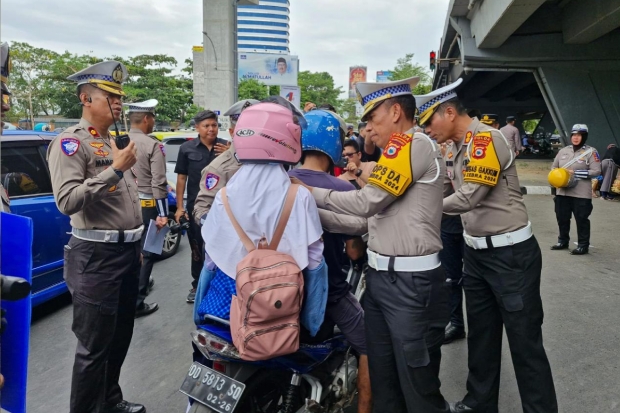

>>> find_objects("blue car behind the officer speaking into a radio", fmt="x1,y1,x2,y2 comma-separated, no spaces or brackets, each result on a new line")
0,130,71,306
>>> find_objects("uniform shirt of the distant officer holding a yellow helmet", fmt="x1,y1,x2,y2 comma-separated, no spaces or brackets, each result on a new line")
553,145,601,199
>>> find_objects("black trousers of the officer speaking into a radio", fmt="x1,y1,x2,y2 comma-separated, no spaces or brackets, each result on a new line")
64,237,140,413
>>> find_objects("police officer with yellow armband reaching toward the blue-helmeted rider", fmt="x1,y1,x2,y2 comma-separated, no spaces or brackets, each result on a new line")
296,77,450,413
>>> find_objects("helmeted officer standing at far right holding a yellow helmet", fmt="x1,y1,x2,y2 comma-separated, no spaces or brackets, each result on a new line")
551,124,601,255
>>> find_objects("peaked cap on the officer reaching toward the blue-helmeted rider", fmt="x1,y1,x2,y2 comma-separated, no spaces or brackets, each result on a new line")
355,76,420,122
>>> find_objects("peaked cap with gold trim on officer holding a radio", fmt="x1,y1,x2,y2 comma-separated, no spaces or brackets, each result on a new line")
67,60,129,96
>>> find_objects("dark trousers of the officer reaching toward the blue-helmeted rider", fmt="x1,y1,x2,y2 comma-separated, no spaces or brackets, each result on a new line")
363,267,450,413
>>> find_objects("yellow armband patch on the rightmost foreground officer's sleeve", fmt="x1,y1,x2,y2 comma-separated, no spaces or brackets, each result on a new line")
463,131,501,186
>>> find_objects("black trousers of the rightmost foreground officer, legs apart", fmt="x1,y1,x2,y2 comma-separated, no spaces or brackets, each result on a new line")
463,237,558,413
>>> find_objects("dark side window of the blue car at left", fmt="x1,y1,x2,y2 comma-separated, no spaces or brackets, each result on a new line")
1,144,52,198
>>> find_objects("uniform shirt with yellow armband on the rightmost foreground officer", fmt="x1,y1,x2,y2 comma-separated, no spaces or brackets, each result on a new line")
443,118,528,237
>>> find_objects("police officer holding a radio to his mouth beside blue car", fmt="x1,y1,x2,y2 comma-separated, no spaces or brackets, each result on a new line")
47,61,146,413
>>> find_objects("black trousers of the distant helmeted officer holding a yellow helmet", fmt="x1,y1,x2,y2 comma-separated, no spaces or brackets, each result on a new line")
554,195,592,247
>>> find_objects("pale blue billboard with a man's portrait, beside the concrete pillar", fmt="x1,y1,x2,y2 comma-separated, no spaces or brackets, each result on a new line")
239,53,299,86
